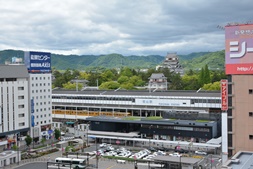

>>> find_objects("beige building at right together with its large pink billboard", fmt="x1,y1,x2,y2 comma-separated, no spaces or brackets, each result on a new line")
223,24,253,156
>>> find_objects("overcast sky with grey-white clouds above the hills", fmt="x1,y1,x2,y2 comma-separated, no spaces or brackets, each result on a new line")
0,0,253,56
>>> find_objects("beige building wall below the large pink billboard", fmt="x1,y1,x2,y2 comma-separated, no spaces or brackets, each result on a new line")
228,75,253,156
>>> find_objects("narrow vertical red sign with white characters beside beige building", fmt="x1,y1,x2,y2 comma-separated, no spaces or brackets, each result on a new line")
221,79,228,111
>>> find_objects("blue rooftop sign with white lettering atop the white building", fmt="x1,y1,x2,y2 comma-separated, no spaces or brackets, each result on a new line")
24,52,51,72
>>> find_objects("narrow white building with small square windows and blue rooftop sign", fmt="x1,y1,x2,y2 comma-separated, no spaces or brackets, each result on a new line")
24,52,52,139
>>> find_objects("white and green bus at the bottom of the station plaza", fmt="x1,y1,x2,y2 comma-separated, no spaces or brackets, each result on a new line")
55,157,86,169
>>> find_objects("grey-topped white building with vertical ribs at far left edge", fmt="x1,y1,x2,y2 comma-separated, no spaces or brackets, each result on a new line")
0,65,30,152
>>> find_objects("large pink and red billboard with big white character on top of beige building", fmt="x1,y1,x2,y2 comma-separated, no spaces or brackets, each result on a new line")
225,24,253,74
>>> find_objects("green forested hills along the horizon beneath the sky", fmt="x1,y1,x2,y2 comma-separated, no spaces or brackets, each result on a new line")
0,50,225,70
